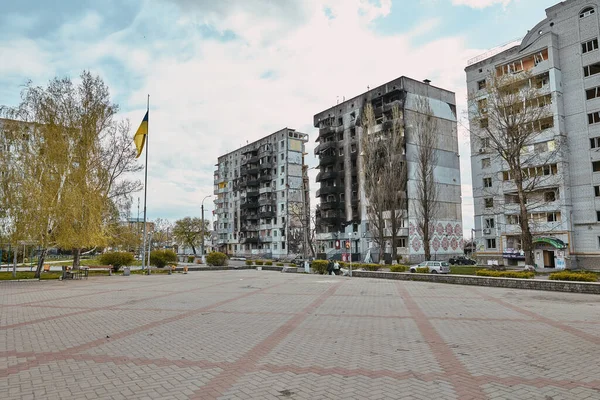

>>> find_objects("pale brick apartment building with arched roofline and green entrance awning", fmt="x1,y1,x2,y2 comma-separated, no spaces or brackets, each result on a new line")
465,0,600,269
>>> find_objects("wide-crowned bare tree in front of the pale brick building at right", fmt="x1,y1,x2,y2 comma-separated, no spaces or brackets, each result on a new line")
469,72,565,265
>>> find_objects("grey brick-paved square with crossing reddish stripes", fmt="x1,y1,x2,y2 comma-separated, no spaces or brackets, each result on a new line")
0,270,600,400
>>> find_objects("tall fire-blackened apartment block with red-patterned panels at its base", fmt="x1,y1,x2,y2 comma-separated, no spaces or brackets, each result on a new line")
314,77,463,262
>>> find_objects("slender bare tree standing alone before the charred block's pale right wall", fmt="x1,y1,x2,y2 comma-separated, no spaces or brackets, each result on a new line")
411,96,439,260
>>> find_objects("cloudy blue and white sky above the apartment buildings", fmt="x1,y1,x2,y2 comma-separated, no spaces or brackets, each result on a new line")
0,0,557,236
